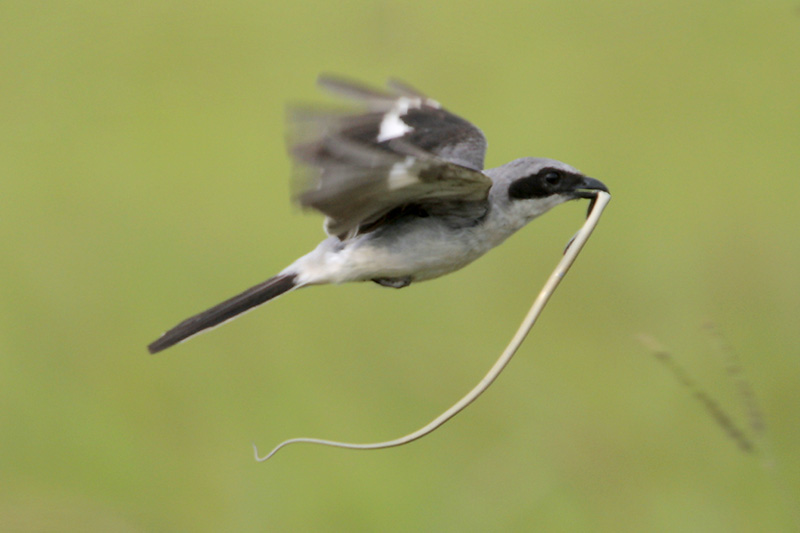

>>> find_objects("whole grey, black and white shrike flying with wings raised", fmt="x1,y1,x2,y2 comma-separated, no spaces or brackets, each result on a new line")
148,77,608,353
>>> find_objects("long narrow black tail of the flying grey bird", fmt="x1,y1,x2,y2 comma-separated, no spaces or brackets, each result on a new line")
147,274,297,353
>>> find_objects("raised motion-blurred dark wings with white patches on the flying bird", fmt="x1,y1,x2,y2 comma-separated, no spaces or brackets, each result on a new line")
290,77,492,238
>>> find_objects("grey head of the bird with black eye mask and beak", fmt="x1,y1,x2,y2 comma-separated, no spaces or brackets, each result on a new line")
486,157,608,220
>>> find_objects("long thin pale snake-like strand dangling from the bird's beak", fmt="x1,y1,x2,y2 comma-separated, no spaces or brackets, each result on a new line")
253,192,611,462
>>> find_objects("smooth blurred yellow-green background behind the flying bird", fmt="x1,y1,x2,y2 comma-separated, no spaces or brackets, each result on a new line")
0,0,800,532
